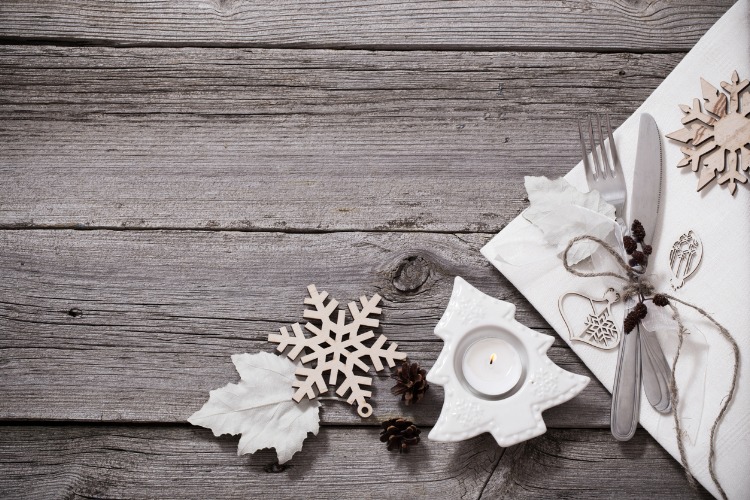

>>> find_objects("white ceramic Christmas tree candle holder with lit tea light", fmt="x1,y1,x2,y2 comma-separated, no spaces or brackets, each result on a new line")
427,277,589,446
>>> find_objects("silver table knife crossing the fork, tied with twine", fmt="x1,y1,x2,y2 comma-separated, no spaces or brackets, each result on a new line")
610,113,663,441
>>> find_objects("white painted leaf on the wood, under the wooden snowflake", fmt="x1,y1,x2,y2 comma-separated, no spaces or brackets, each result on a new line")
188,352,320,464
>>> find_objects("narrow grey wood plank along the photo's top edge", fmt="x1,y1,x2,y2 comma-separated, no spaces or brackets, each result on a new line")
0,0,733,51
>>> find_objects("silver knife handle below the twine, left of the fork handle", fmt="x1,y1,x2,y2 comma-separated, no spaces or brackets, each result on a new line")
610,327,641,441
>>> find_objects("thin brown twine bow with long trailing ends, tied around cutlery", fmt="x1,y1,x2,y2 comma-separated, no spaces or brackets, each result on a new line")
563,235,740,499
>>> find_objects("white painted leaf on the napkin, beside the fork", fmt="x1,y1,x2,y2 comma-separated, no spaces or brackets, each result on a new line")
523,177,615,264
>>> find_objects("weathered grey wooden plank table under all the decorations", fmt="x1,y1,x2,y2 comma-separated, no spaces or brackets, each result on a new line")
0,0,732,498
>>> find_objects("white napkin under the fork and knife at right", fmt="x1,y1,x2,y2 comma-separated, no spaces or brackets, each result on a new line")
482,0,750,498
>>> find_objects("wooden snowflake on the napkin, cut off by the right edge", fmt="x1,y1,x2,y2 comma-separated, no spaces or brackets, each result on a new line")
667,71,750,195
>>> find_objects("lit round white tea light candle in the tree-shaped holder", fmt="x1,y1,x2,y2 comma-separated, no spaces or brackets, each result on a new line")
461,337,523,396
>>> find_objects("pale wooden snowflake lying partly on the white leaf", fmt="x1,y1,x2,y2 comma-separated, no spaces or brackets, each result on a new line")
268,285,406,417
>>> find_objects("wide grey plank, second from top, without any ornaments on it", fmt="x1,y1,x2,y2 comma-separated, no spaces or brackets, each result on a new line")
0,44,682,233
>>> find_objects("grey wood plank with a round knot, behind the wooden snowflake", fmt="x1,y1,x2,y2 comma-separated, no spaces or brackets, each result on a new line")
0,230,609,427
